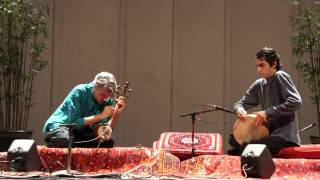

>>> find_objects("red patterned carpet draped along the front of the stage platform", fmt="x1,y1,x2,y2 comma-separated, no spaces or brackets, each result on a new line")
0,146,320,179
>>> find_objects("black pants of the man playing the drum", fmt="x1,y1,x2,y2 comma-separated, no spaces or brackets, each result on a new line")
228,134,299,156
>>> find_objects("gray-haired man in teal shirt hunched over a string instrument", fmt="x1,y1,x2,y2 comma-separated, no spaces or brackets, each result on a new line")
43,72,125,147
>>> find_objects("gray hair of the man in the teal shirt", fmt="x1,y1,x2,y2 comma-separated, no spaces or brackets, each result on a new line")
92,72,117,95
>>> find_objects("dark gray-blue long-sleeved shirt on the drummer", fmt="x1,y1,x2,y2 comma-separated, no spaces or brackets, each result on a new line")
234,71,302,145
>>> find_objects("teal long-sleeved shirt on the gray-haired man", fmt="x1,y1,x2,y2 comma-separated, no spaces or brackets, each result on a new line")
42,83,113,133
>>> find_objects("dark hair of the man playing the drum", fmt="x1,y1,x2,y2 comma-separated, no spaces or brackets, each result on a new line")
256,47,281,71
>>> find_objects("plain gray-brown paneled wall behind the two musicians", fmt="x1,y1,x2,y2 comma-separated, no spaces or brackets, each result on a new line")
29,0,317,152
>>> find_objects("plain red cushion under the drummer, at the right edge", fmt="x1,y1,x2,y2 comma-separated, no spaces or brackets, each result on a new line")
276,144,320,159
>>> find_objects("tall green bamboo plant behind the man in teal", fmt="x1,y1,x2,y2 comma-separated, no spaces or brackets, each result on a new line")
0,0,49,131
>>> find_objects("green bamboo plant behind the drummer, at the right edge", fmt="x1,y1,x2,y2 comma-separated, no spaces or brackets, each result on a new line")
291,0,320,132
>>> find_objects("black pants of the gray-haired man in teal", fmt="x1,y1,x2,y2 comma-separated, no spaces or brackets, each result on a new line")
45,127,114,148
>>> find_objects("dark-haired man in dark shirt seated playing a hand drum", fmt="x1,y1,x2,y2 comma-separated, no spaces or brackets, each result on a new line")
228,47,302,155
